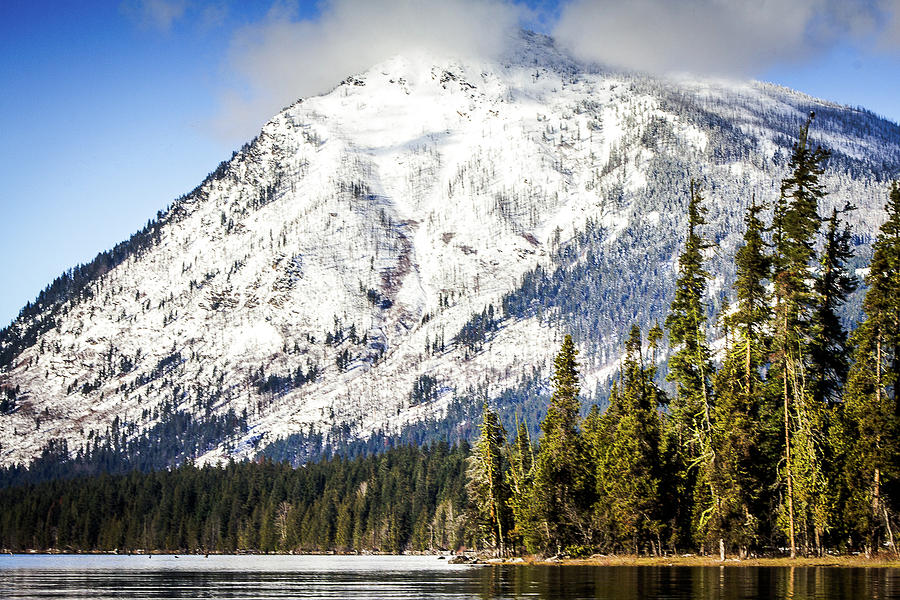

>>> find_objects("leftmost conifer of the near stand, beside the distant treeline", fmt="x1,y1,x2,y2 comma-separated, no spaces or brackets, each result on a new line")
466,402,509,556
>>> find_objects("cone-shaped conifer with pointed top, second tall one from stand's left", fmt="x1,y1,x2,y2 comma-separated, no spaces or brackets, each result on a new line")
534,335,590,553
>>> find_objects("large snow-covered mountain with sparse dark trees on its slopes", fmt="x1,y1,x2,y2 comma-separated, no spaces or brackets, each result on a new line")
0,33,900,472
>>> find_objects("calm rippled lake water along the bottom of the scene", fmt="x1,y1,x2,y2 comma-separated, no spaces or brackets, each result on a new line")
0,555,900,600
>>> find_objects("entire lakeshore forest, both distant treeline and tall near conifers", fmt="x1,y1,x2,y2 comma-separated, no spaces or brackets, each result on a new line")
0,116,900,557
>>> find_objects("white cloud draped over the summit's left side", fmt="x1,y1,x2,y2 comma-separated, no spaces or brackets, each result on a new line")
210,0,526,139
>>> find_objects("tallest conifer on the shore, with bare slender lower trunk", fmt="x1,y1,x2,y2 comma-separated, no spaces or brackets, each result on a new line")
770,113,829,557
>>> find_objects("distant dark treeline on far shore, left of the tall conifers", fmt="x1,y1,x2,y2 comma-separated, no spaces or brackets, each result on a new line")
0,443,469,552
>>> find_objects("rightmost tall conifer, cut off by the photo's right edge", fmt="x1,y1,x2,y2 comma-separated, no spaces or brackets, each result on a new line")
842,182,900,553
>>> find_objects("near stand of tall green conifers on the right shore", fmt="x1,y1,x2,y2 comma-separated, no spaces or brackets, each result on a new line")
468,115,900,558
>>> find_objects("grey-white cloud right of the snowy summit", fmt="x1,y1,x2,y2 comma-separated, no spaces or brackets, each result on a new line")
553,0,900,75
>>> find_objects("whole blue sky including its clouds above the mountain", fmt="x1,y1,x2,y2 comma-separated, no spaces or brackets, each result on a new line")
0,0,900,327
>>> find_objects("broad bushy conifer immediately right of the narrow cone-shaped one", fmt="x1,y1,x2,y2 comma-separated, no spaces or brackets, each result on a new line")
590,325,664,554
